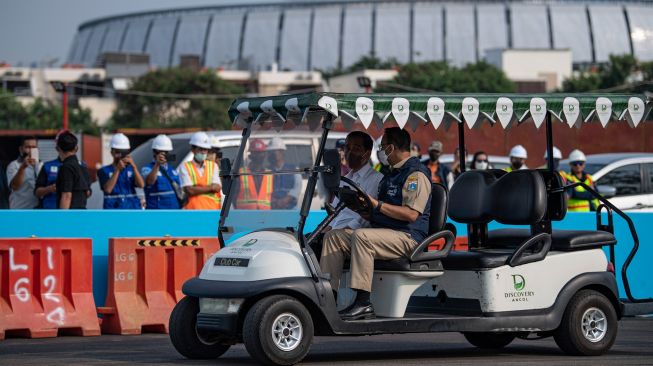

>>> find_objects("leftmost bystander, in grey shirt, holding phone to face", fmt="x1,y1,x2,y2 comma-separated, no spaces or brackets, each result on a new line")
7,136,43,209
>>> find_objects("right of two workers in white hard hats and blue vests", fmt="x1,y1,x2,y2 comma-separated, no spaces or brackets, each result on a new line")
141,135,181,210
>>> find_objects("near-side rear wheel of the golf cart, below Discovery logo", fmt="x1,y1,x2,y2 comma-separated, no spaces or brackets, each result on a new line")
553,290,618,356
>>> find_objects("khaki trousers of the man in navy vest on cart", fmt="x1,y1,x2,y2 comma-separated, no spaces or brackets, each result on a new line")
320,228,417,292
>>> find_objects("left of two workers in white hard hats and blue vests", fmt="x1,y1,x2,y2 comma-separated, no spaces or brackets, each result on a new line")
98,133,145,210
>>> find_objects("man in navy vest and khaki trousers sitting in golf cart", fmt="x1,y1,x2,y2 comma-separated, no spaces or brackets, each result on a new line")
320,127,431,320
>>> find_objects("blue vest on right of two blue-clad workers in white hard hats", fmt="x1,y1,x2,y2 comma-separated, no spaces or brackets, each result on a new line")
141,162,181,210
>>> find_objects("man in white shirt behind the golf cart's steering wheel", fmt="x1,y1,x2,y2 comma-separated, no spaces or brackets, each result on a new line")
325,131,383,231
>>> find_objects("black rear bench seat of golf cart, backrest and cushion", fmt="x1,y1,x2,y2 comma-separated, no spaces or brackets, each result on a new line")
442,170,551,270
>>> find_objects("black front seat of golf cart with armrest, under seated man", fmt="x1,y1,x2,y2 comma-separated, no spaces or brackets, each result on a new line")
374,183,456,271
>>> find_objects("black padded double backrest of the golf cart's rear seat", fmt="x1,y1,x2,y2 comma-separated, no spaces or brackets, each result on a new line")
448,170,547,225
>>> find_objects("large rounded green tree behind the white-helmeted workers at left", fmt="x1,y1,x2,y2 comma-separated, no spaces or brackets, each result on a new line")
109,68,243,129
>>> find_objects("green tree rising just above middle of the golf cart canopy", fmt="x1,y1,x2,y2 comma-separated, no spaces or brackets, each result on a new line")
375,61,516,93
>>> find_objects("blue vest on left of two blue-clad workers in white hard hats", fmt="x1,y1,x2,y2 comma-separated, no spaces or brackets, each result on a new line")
97,164,141,210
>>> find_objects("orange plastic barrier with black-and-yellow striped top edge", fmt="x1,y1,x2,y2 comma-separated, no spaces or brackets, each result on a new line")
98,238,220,334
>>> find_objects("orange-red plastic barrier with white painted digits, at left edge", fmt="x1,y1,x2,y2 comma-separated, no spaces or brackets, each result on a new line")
0,238,100,339
